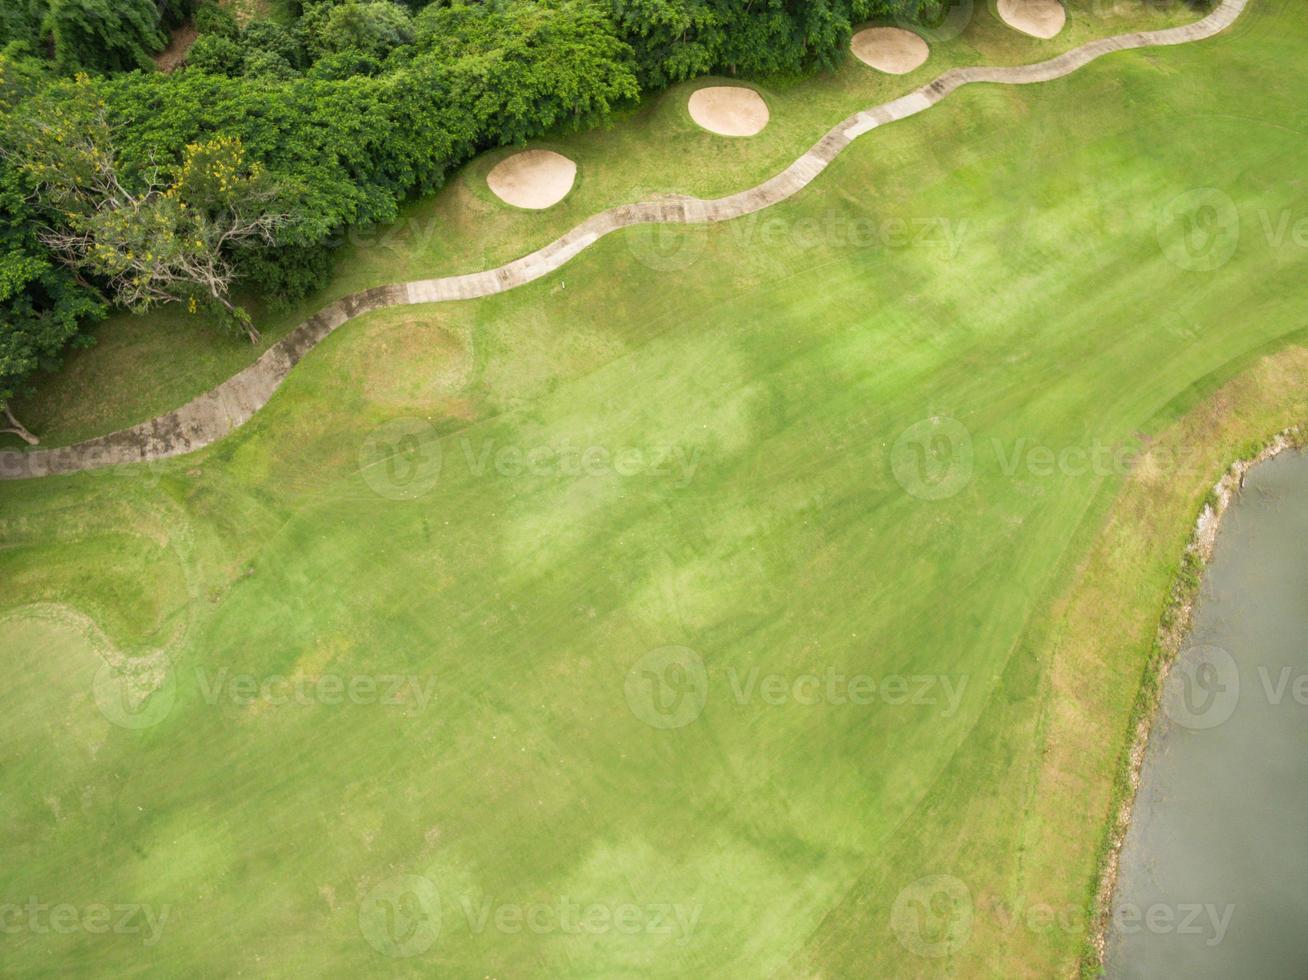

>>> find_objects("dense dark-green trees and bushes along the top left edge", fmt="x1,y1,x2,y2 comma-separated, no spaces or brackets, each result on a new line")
0,0,938,437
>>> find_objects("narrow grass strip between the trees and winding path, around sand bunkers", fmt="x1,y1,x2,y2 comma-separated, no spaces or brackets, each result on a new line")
0,3,1194,447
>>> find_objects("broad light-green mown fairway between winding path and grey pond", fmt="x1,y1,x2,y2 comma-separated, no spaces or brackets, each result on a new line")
0,3,1308,977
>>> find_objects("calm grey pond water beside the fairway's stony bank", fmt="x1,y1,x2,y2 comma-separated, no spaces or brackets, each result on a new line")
1107,453,1308,977
